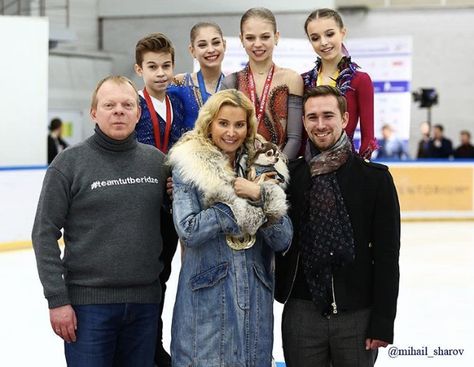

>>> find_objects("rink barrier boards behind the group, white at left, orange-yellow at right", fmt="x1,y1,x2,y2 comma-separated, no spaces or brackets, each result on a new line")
0,160,474,252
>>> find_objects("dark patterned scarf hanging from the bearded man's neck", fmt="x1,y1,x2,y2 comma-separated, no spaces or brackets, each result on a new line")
300,132,355,313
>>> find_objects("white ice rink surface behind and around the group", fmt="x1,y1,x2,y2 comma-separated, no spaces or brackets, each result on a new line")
0,221,474,367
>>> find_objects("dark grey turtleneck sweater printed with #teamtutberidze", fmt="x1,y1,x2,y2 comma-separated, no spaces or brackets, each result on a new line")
32,126,166,308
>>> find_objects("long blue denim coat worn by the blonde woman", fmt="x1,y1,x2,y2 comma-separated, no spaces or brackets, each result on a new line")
170,136,292,367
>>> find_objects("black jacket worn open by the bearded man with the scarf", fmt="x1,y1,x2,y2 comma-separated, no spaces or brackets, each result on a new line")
275,156,400,343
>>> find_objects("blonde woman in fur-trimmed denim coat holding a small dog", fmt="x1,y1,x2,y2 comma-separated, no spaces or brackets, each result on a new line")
169,89,293,367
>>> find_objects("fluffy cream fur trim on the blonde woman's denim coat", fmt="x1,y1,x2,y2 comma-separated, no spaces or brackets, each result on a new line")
168,134,287,234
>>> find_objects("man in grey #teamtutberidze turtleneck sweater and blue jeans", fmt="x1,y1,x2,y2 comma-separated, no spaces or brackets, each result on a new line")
32,77,166,367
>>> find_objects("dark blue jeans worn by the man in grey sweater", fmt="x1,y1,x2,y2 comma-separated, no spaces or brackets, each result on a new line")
64,303,158,367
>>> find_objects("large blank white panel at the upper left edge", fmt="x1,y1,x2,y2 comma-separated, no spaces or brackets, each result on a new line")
0,16,49,166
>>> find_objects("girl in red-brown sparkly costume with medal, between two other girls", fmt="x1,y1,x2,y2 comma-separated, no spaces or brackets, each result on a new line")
223,8,303,159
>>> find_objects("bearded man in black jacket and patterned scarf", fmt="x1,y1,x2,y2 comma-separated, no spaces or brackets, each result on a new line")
275,86,400,367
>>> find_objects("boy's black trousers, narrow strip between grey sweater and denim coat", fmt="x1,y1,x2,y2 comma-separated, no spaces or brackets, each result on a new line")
155,209,178,362
